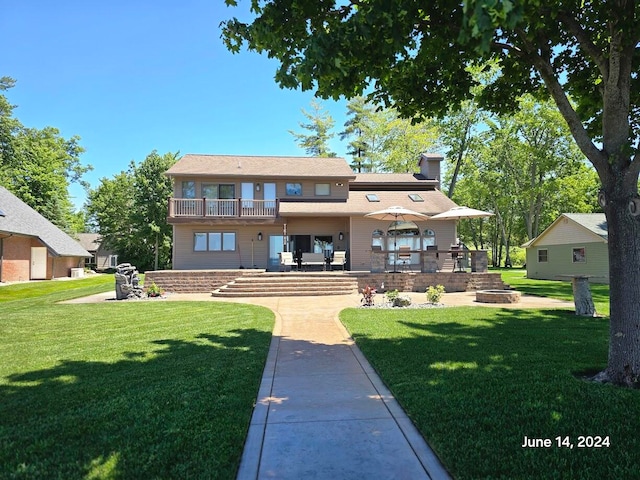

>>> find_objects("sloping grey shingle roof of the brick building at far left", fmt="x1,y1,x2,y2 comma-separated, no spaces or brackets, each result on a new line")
0,187,91,257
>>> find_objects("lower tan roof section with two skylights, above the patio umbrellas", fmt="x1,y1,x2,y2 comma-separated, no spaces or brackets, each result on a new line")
280,190,457,216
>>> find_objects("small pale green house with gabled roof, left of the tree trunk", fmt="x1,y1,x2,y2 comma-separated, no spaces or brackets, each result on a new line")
523,213,609,283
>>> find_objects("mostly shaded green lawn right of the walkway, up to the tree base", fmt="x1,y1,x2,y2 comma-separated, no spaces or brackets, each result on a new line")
347,307,640,478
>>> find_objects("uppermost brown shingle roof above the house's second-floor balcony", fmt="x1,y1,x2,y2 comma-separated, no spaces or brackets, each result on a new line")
167,154,355,179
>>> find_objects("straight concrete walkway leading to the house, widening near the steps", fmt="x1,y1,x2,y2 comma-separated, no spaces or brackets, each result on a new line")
230,296,449,480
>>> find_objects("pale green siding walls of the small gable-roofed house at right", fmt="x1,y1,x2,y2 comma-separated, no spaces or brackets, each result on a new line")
527,242,609,283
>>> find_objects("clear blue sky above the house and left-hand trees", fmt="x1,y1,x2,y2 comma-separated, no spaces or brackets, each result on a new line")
0,0,346,206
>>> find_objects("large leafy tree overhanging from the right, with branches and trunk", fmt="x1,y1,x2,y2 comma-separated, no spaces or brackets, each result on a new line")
222,0,640,386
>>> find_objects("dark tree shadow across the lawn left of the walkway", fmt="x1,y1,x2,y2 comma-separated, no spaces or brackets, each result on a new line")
0,329,271,479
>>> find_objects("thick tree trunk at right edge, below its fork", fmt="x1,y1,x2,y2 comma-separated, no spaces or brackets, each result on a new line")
605,189,640,388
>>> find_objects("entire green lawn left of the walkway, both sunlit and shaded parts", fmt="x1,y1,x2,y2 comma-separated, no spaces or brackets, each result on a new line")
0,276,274,479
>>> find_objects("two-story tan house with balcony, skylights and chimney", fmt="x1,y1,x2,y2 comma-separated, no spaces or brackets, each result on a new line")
167,155,456,271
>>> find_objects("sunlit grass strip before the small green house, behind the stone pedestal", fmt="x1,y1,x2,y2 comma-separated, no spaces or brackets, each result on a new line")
500,268,609,316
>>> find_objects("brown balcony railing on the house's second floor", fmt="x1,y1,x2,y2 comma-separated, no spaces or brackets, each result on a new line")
169,198,278,218
